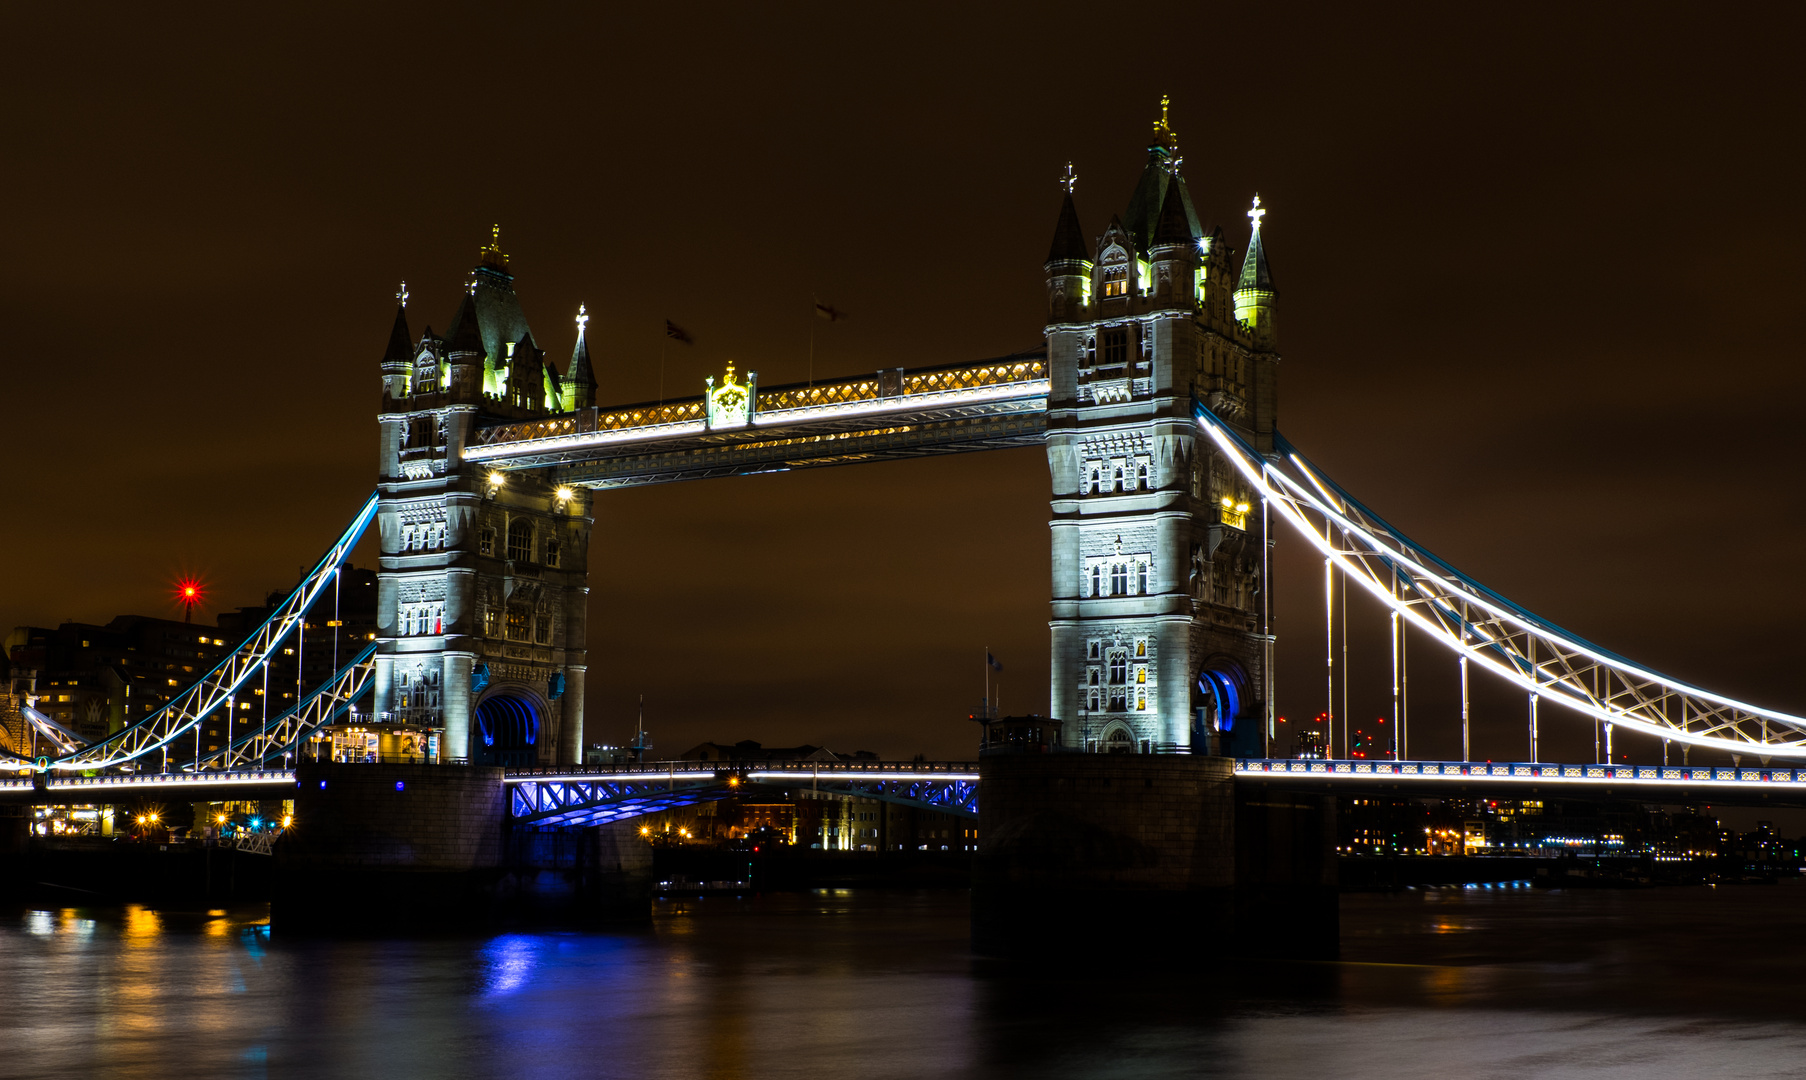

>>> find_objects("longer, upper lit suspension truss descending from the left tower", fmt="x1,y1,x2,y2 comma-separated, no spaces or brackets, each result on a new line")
47,495,376,771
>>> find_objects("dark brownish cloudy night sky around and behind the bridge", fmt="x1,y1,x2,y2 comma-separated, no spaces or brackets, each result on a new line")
0,5,1806,760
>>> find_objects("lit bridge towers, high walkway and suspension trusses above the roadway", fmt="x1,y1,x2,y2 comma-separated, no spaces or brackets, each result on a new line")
14,99,1806,787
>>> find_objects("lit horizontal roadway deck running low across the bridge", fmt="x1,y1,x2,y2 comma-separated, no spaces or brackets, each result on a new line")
0,759,1806,813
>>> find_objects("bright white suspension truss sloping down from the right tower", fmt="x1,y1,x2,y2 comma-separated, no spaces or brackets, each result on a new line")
1194,405,1806,760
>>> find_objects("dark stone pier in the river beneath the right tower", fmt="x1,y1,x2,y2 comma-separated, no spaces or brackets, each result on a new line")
972,753,1338,966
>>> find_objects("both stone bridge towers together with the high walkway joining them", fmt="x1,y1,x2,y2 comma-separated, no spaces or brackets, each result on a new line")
372,101,1279,766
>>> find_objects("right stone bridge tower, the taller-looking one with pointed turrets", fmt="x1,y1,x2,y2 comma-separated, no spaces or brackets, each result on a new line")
1046,99,1279,753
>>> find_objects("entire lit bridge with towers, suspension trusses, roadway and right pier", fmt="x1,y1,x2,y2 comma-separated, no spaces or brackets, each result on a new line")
0,108,1806,939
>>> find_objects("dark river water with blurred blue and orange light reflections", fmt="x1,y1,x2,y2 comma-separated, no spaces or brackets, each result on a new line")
0,883,1806,1080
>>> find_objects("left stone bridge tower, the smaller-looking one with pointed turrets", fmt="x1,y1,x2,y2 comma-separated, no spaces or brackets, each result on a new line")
368,229,596,766
